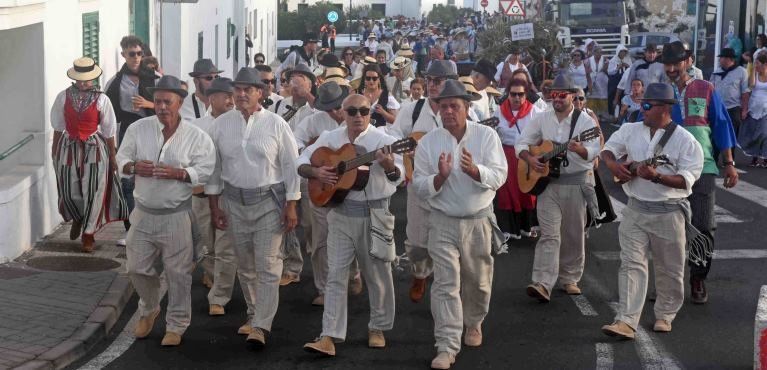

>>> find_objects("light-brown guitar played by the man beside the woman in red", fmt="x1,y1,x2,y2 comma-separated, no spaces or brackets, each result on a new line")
517,127,600,195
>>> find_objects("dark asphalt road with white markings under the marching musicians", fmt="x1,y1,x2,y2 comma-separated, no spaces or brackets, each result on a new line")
71,151,767,370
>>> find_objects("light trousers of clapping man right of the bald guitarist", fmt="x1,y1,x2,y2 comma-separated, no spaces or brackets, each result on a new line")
428,209,493,354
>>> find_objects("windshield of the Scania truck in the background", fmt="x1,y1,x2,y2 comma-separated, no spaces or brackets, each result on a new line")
559,0,625,27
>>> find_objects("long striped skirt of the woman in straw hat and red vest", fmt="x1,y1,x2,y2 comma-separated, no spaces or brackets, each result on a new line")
54,133,128,235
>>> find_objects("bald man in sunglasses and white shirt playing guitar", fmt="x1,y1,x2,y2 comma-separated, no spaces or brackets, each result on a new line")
297,94,404,356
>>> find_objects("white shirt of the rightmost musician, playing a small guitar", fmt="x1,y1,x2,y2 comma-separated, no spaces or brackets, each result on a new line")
602,122,703,201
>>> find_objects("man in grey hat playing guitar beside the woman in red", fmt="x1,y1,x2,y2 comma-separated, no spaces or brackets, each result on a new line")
514,74,600,302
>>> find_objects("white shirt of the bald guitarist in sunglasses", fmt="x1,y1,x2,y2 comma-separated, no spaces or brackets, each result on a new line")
293,124,405,201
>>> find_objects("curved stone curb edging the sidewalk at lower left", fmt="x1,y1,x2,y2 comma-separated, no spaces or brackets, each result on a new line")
14,273,133,370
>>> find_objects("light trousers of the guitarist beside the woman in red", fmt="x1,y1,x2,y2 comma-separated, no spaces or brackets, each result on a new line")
533,183,586,292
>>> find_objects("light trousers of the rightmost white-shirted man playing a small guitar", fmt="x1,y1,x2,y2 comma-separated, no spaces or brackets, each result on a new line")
615,207,686,328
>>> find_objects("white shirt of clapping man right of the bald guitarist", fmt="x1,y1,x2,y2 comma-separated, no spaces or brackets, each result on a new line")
413,122,508,217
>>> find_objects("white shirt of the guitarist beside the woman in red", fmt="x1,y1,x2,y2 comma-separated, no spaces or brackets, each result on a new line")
514,109,600,174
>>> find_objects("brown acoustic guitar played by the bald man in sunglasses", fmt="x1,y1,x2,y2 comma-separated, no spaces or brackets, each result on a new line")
309,138,416,207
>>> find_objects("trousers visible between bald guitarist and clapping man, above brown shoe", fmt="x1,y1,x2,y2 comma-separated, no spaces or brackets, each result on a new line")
405,185,434,279
